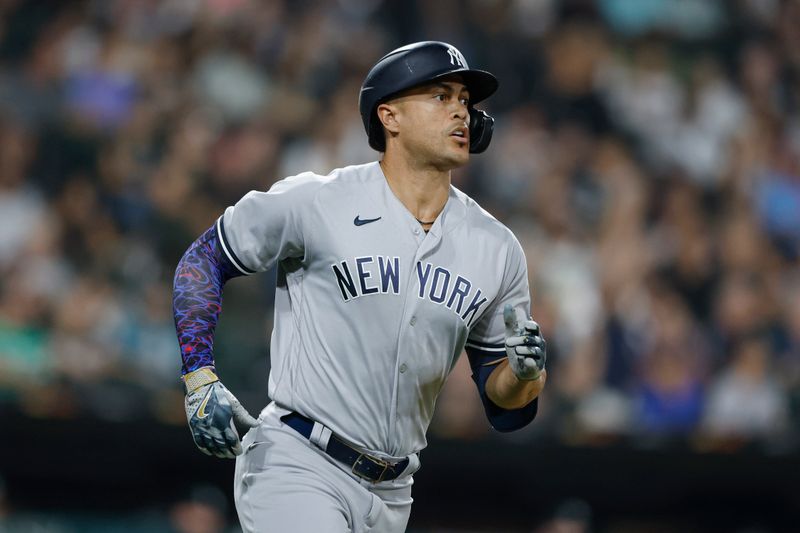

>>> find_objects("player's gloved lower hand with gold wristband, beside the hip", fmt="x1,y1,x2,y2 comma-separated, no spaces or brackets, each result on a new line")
183,367,258,459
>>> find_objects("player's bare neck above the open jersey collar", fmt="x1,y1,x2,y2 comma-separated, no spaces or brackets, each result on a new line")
381,157,450,221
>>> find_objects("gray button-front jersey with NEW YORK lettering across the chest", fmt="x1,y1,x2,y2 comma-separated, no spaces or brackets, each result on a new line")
217,162,530,458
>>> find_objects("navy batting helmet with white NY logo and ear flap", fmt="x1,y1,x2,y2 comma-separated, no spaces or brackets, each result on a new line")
358,41,498,154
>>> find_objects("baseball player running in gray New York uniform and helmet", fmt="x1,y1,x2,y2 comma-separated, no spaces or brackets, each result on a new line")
174,41,546,533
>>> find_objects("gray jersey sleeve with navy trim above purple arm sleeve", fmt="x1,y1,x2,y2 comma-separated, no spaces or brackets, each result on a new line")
217,173,324,274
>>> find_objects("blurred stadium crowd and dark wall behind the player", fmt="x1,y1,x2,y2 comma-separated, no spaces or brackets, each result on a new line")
0,0,800,533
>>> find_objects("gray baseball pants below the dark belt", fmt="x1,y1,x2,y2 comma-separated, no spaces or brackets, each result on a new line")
233,404,419,533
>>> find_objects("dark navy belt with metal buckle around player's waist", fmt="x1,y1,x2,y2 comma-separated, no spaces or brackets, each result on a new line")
281,413,408,483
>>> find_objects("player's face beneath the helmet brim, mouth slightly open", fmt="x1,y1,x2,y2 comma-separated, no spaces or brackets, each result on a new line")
382,76,469,170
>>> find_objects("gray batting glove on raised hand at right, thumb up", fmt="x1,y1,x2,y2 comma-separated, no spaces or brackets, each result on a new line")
503,304,547,381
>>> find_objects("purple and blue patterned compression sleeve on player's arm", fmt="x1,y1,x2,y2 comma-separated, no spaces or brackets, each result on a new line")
172,224,242,374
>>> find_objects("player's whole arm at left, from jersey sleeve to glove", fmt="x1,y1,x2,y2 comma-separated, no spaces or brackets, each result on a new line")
173,175,319,457
